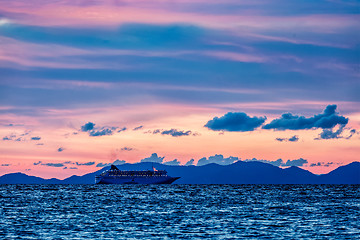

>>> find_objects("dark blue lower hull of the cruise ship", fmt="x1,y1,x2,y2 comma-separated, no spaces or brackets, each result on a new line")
95,176,179,184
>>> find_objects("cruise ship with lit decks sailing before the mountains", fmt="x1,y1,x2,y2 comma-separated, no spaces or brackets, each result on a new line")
95,165,180,184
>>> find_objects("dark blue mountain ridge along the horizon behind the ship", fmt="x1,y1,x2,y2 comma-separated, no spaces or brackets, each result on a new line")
0,161,360,184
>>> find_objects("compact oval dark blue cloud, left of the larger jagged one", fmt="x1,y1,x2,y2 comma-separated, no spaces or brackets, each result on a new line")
205,112,266,132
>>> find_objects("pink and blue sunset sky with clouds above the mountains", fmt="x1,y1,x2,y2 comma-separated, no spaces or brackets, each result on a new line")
0,0,360,179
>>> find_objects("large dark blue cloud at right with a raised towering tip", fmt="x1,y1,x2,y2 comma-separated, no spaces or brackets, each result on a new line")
262,105,349,130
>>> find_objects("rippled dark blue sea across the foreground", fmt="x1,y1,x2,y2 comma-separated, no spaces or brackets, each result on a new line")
0,185,360,239
